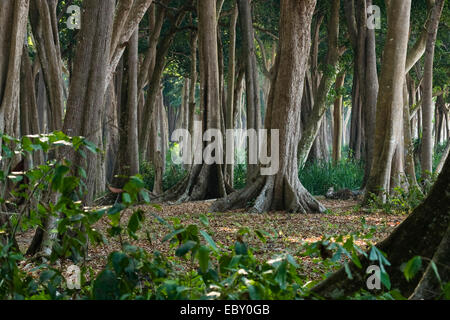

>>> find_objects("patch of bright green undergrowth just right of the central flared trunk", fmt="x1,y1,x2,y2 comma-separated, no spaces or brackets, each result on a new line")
299,160,364,195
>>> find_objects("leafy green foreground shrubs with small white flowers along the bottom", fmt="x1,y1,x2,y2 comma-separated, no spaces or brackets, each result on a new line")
0,133,449,300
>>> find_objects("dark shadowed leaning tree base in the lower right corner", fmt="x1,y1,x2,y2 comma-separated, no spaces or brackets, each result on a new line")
313,151,450,299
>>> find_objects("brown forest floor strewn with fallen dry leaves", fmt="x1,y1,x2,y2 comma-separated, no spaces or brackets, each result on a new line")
17,197,406,280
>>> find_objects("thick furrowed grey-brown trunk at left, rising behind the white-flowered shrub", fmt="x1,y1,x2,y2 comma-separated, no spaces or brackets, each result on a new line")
64,0,115,203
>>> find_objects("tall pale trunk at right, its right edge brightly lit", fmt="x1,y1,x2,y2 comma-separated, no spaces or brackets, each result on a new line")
365,0,411,202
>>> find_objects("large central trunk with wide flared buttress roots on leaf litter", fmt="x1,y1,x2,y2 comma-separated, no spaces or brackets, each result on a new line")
210,0,325,213
